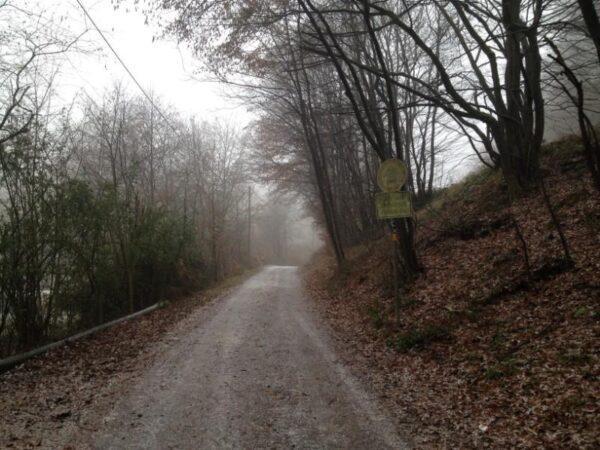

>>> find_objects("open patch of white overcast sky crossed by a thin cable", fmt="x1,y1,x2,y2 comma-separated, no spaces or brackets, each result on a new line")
35,0,251,126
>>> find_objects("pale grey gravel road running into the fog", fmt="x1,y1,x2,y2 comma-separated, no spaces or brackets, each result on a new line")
87,266,408,449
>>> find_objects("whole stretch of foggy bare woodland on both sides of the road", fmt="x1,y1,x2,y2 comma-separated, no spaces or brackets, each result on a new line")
0,0,600,353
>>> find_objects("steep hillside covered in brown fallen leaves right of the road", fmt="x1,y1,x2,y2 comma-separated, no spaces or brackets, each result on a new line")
307,137,600,448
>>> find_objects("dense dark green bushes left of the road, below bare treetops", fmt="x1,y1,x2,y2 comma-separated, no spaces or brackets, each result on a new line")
0,173,206,354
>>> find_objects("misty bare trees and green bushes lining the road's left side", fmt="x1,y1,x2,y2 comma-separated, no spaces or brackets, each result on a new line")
0,1,288,359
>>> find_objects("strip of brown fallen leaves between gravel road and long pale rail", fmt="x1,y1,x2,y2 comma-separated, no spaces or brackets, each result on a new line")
0,290,227,448
